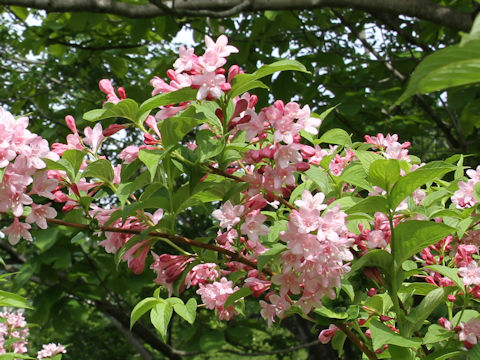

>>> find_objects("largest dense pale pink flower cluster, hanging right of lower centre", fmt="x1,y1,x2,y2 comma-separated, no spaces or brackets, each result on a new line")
261,190,353,321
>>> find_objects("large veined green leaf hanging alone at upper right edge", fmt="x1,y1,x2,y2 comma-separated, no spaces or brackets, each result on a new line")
394,40,480,105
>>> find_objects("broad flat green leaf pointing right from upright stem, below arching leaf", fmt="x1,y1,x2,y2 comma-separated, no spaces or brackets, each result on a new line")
392,220,454,264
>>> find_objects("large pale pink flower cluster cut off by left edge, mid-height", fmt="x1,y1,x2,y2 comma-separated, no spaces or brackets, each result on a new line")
0,107,59,245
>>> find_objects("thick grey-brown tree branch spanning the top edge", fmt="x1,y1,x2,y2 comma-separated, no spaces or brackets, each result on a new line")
0,0,473,32
